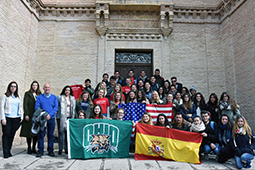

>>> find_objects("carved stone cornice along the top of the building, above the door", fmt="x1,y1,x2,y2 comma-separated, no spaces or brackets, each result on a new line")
21,0,246,39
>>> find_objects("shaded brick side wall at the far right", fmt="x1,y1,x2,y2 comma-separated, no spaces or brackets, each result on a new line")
222,0,255,129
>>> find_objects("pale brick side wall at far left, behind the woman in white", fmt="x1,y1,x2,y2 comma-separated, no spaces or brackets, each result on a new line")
0,0,38,144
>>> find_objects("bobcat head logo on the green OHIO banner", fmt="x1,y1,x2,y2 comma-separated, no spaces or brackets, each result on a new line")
85,134,117,154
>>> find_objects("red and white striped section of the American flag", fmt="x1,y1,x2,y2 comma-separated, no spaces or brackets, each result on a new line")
146,104,174,124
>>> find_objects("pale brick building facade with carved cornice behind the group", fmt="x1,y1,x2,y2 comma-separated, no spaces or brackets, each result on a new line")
0,0,255,143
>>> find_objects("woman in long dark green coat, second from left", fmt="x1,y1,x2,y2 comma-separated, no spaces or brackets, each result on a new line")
20,81,42,154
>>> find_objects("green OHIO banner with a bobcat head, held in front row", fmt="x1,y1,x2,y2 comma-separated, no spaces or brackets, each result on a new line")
67,119,133,159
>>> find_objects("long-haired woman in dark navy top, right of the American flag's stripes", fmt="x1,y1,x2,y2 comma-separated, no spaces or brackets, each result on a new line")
180,94,197,122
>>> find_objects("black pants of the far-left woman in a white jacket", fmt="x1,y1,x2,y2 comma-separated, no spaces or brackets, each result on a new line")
2,117,20,158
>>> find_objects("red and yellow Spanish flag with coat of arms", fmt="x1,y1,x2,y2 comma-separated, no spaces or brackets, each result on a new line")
135,123,203,164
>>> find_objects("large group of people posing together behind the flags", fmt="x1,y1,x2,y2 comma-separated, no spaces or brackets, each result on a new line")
1,69,254,168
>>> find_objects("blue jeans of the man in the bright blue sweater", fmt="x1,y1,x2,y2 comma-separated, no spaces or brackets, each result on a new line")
38,118,55,153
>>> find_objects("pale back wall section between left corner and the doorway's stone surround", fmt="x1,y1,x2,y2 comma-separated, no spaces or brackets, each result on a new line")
35,21,98,95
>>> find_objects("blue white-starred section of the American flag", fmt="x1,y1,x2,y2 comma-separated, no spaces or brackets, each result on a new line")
119,103,145,122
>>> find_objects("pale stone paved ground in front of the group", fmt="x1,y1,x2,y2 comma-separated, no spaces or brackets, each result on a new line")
0,145,251,170
